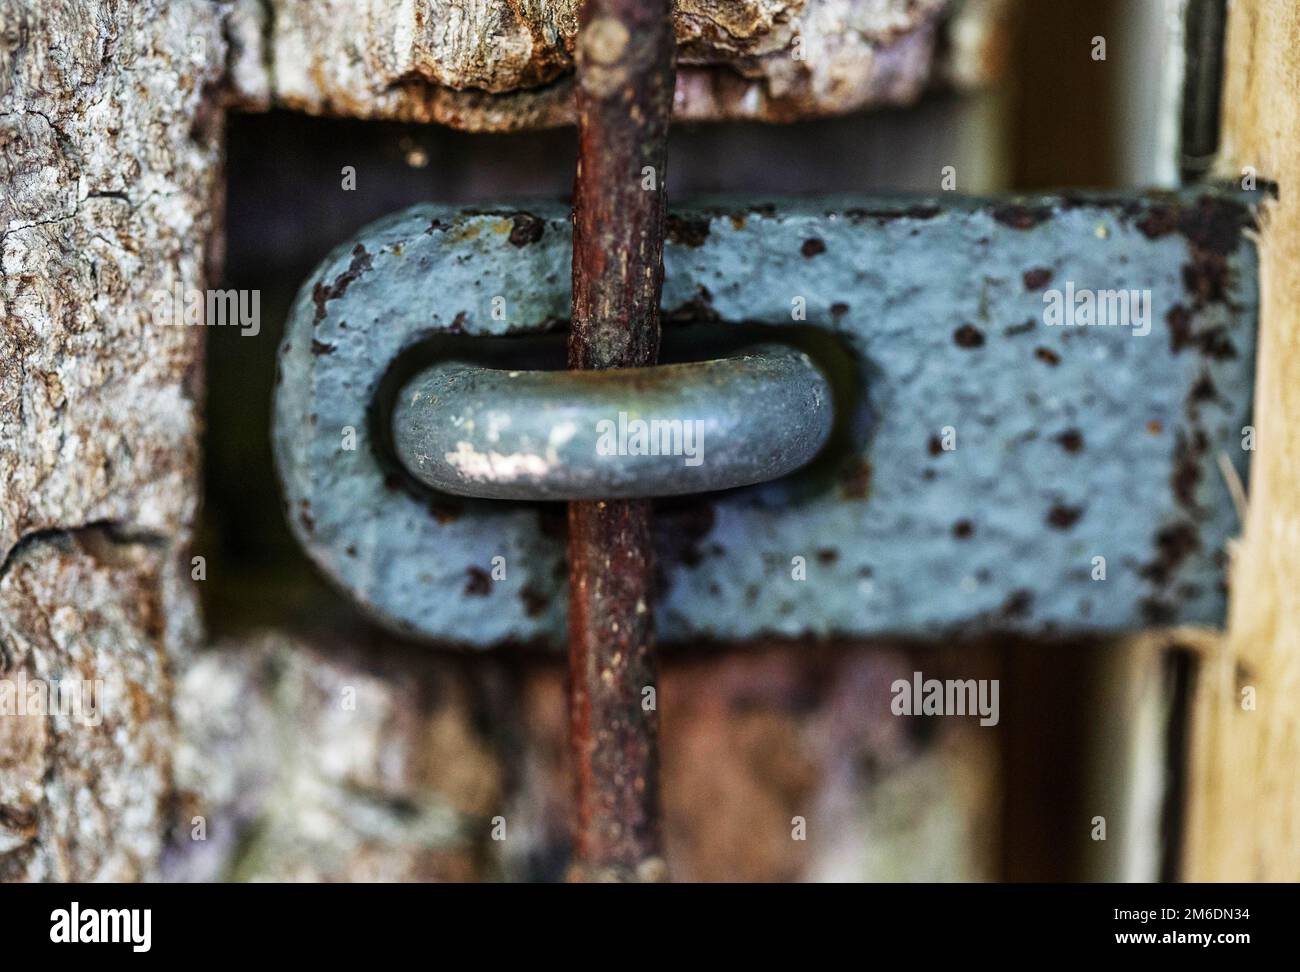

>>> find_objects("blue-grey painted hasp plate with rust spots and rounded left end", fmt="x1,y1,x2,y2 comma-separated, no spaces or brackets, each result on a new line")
274,192,1257,647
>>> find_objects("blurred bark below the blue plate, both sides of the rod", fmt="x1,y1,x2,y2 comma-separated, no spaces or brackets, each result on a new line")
164,632,998,881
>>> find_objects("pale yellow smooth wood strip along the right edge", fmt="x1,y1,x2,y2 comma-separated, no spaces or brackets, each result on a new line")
1187,0,1300,881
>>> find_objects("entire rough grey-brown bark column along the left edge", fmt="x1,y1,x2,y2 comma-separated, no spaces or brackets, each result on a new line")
0,0,225,880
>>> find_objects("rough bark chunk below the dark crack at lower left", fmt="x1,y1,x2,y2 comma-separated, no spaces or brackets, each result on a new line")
0,528,195,881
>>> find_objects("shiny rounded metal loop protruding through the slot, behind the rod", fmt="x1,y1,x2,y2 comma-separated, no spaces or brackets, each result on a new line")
393,344,833,500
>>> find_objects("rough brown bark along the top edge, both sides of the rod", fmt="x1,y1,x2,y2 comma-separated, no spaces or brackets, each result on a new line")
229,0,1010,131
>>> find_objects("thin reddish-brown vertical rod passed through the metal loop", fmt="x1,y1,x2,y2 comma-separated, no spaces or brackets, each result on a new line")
568,0,676,881
